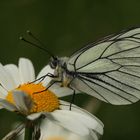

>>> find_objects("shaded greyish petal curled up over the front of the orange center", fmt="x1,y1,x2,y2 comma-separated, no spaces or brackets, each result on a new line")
13,90,33,114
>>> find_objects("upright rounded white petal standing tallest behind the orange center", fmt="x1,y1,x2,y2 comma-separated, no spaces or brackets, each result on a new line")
19,58,35,83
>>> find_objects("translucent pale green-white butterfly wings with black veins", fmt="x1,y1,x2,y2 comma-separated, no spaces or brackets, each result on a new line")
67,28,140,105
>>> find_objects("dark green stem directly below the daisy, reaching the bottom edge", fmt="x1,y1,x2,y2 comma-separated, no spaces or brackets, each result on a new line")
24,120,34,140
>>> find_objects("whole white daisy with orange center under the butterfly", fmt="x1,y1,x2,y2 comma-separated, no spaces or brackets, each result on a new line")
0,58,103,136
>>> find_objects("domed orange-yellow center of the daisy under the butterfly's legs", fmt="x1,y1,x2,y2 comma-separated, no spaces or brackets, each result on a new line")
6,83,59,113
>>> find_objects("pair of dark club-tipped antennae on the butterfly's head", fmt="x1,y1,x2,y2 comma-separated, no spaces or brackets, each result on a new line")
19,30,55,58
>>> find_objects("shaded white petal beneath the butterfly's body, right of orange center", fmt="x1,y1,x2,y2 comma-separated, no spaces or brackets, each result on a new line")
49,84,73,97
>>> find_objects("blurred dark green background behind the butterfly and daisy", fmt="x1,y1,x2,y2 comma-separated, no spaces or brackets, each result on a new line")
0,0,140,140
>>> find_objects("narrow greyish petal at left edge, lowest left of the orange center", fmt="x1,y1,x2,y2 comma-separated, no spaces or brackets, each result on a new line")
0,99,17,111
